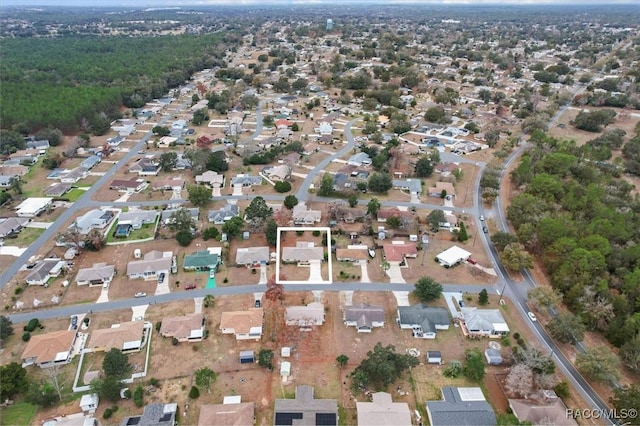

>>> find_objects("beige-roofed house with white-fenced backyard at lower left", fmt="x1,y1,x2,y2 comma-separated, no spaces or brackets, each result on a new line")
86,321,148,352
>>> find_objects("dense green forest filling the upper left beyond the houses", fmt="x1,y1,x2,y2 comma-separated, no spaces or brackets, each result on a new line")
0,33,240,132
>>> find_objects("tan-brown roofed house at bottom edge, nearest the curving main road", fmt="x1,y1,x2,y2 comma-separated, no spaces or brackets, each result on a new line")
509,390,578,426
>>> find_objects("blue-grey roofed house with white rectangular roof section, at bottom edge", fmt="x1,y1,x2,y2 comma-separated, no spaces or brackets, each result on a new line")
427,386,497,426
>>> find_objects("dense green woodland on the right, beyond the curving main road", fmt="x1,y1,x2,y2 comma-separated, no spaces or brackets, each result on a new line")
508,125,640,349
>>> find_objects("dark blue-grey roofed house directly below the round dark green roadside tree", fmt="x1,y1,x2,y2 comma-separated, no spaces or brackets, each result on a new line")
398,303,451,339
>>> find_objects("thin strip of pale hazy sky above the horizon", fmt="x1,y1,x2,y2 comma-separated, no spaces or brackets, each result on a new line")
0,0,638,8
